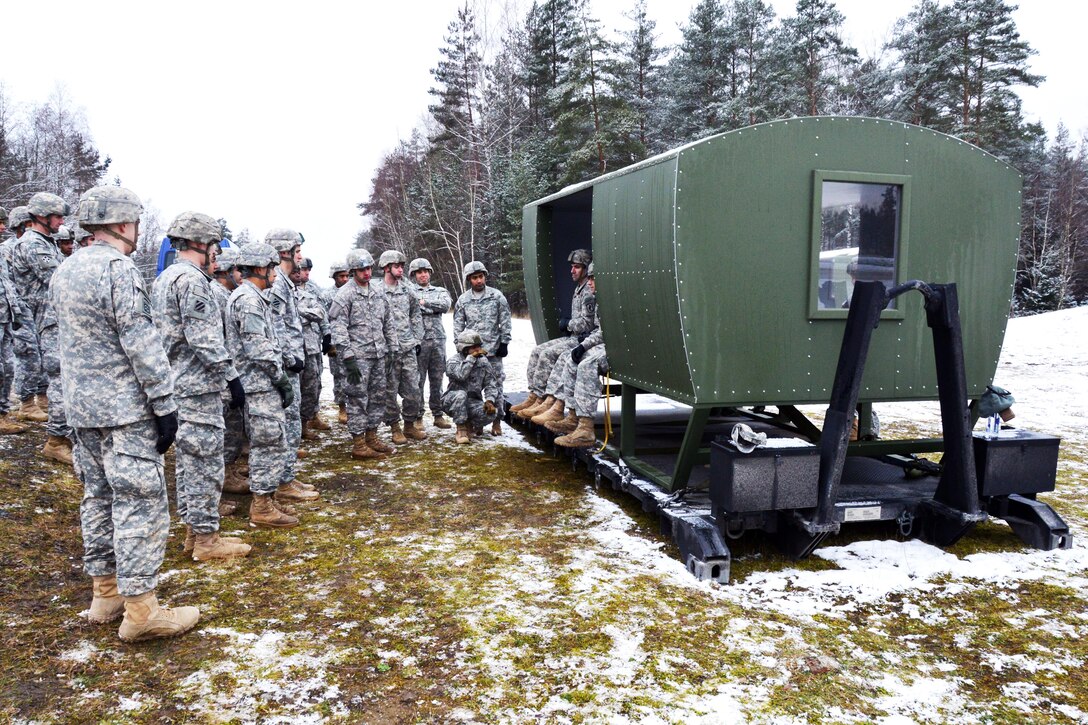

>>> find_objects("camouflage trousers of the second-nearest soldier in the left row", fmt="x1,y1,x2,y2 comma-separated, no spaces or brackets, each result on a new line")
175,393,223,533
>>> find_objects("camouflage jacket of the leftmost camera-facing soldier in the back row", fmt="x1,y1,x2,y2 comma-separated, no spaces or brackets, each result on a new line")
329,280,397,361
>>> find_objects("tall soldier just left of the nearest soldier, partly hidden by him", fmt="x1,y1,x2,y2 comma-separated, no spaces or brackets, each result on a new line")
12,192,72,465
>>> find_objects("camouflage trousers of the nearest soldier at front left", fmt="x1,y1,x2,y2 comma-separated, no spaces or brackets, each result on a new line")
74,420,170,597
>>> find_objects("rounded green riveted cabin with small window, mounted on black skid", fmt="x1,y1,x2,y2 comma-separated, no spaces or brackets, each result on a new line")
522,116,1022,408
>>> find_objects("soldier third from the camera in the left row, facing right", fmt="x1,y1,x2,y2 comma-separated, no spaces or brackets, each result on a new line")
226,242,298,529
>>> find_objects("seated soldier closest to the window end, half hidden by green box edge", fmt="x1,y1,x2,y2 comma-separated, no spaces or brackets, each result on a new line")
545,263,608,448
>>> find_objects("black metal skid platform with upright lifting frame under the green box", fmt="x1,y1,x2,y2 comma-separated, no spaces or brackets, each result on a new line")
508,281,1073,583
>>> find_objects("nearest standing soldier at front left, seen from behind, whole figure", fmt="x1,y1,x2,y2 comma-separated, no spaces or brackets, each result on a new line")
50,186,200,641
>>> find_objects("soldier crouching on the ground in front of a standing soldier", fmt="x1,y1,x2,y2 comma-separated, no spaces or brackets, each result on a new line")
442,330,499,443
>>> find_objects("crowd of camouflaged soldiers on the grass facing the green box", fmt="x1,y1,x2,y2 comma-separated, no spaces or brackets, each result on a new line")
0,186,520,641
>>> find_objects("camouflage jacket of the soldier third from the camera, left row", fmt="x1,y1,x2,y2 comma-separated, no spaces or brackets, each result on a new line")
226,280,283,393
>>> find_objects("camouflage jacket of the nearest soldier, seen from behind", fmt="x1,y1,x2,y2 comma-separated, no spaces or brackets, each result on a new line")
50,242,177,428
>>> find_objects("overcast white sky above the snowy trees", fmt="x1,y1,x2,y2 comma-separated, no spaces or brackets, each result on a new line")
0,0,1088,277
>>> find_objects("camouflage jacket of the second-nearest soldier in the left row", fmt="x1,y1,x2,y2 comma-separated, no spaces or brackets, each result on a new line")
151,259,238,397
